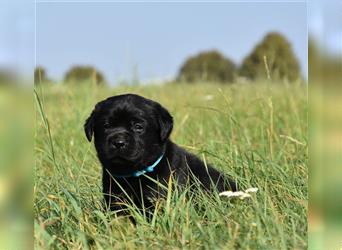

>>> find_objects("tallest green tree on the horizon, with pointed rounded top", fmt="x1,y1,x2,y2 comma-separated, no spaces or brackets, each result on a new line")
239,32,301,81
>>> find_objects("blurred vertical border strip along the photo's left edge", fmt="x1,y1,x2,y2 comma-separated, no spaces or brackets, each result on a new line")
0,0,35,249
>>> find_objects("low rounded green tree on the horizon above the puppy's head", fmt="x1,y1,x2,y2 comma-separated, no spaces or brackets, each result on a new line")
64,65,106,85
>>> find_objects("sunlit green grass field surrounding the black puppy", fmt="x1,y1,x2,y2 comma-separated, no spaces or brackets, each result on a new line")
34,83,308,250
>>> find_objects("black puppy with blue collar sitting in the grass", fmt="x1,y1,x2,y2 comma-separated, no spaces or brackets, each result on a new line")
84,94,237,213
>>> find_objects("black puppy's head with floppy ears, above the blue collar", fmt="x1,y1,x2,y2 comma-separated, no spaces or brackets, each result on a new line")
84,94,173,175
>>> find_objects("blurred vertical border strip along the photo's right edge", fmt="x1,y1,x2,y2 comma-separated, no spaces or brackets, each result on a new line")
308,0,342,249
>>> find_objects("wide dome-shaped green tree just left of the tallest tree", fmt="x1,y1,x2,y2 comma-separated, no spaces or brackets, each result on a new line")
177,50,235,83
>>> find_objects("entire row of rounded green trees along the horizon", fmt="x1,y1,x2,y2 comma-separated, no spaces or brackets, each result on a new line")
34,32,301,85
